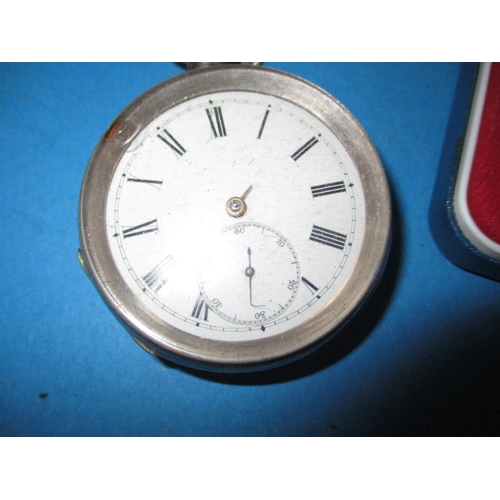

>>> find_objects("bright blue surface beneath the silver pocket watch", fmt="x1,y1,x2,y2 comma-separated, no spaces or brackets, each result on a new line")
0,63,500,436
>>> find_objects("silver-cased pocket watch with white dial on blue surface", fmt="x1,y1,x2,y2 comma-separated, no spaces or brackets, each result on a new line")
79,63,391,372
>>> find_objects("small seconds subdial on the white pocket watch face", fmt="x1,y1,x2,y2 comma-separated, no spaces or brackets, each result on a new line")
199,222,300,329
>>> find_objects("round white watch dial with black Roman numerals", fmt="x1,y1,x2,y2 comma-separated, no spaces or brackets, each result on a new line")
106,91,365,342
